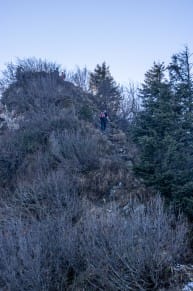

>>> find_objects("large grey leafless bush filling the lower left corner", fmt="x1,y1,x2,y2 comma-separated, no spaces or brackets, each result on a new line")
0,164,83,290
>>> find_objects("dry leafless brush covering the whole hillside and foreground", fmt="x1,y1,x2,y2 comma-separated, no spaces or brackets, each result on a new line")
0,61,188,291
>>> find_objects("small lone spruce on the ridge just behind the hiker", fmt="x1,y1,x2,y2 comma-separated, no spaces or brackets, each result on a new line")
90,62,121,116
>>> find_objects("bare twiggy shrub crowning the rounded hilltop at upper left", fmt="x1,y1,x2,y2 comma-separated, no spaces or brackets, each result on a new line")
1,58,60,113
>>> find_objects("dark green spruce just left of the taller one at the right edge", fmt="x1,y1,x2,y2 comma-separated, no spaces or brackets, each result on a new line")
134,63,175,195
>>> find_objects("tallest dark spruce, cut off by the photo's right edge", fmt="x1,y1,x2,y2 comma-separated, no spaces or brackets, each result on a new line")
169,47,193,216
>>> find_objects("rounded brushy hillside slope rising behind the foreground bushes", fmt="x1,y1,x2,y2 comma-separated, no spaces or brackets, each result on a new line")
0,76,144,206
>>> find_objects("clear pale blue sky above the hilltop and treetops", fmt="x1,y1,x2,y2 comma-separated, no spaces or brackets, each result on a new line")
0,0,193,83
